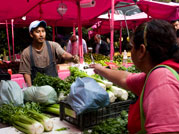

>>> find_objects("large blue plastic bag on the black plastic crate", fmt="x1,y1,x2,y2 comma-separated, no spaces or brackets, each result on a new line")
67,77,109,115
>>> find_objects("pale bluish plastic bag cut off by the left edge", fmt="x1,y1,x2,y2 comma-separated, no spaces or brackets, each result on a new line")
0,80,24,105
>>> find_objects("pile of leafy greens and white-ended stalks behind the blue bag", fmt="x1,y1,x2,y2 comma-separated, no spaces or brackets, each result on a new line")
34,67,135,102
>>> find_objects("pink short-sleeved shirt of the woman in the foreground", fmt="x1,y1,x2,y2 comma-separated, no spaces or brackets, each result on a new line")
127,68,179,134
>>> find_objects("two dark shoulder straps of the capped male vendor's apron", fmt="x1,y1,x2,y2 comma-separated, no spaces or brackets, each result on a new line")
30,41,53,67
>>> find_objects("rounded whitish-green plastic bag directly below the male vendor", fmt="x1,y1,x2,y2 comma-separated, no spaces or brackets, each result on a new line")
24,85,57,104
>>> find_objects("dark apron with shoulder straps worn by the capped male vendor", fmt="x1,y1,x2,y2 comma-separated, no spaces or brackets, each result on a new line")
30,41,58,83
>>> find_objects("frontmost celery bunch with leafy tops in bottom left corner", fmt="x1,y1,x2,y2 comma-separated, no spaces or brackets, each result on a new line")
0,103,44,134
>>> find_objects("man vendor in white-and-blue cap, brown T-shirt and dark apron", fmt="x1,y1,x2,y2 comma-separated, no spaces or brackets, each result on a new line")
19,20,79,86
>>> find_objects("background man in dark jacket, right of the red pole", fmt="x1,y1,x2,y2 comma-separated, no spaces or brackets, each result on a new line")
93,34,110,56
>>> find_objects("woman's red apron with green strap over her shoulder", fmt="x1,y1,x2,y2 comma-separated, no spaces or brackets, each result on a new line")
128,65,179,134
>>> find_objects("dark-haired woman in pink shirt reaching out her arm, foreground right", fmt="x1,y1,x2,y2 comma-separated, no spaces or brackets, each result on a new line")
90,19,179,134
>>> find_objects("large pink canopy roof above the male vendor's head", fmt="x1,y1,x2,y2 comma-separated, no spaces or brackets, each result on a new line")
0,0,133,26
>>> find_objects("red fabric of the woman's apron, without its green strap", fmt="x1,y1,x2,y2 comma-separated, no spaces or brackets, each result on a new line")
128,60,179,134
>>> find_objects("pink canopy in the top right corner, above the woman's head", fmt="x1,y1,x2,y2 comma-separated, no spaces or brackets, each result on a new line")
137,0,179,21
